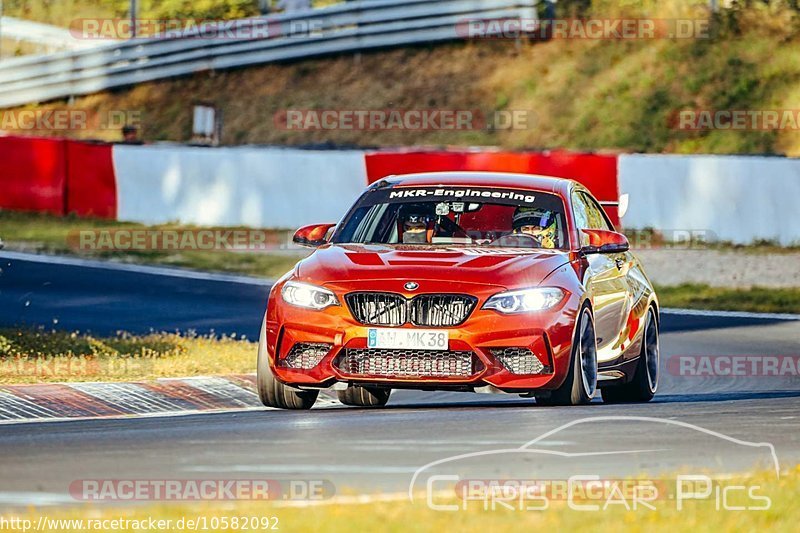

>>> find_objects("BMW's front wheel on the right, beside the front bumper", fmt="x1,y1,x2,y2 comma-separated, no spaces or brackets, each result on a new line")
535,305,597,405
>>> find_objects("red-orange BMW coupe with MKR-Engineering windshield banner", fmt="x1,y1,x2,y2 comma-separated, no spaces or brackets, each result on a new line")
257,172,660,409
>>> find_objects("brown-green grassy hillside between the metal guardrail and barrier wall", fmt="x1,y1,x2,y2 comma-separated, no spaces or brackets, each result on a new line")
6,2,800,156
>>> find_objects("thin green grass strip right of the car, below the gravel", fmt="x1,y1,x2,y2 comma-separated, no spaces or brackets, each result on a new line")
656,283,800,314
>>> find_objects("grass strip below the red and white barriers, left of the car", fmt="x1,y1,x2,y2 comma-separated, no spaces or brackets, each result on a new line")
0,211,305,278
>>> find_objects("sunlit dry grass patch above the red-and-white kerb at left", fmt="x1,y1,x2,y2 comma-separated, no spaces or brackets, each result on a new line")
0,328,256,384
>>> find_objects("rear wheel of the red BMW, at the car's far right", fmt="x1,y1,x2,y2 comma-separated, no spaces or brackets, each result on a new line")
601,307,661,403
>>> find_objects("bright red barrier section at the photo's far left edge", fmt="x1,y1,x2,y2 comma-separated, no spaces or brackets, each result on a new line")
0,137,66,215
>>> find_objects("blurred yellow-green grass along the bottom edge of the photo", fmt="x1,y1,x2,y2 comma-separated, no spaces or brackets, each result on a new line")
6,468,800,533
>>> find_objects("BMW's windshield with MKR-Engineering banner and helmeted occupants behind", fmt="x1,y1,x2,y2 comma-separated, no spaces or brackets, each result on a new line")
333,187,567,249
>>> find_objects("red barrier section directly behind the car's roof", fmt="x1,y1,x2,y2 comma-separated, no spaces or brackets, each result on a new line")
366,150,619,224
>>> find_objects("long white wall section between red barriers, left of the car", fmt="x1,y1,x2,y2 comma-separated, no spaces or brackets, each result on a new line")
113,145,367,228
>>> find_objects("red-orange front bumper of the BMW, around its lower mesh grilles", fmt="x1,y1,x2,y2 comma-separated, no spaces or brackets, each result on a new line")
265,282,580,393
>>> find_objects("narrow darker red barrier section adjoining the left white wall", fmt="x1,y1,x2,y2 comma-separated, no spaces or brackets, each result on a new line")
66,141,117,219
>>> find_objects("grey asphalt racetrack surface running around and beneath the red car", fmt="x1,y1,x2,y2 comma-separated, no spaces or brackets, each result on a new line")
0,252,800,506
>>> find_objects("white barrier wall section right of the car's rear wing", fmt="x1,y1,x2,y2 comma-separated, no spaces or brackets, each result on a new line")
619,155,800,245
